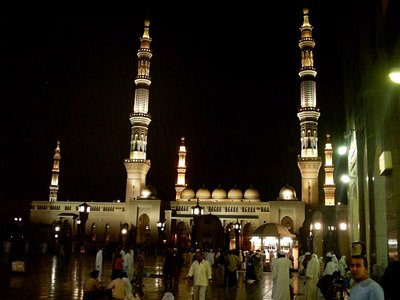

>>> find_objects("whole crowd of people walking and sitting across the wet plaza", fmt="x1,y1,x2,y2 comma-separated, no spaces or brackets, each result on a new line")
84,247,400,300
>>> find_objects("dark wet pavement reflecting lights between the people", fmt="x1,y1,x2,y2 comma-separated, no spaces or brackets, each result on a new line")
0,254,304,300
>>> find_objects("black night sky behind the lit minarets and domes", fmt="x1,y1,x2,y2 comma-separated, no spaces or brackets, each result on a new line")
0,1,344,201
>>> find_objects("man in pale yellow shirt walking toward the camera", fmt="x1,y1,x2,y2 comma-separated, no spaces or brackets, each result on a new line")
187,250,212,300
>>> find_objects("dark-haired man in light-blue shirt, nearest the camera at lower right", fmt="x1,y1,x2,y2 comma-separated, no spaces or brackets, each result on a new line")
349,255,385,300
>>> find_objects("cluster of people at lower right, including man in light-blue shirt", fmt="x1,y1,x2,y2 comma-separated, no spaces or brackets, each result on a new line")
292,247,400,300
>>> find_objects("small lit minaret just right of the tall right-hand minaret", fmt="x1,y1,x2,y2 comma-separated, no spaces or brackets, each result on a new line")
324,134,336,206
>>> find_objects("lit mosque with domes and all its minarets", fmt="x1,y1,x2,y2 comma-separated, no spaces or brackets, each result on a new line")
30,9,346,264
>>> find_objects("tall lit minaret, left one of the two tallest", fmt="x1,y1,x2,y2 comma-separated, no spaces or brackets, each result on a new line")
124,20,153,202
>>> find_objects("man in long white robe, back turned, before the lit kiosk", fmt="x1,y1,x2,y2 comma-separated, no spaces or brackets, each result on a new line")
271,251,293,300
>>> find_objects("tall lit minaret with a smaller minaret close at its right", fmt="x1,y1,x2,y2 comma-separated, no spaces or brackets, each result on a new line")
297,8,321,205
